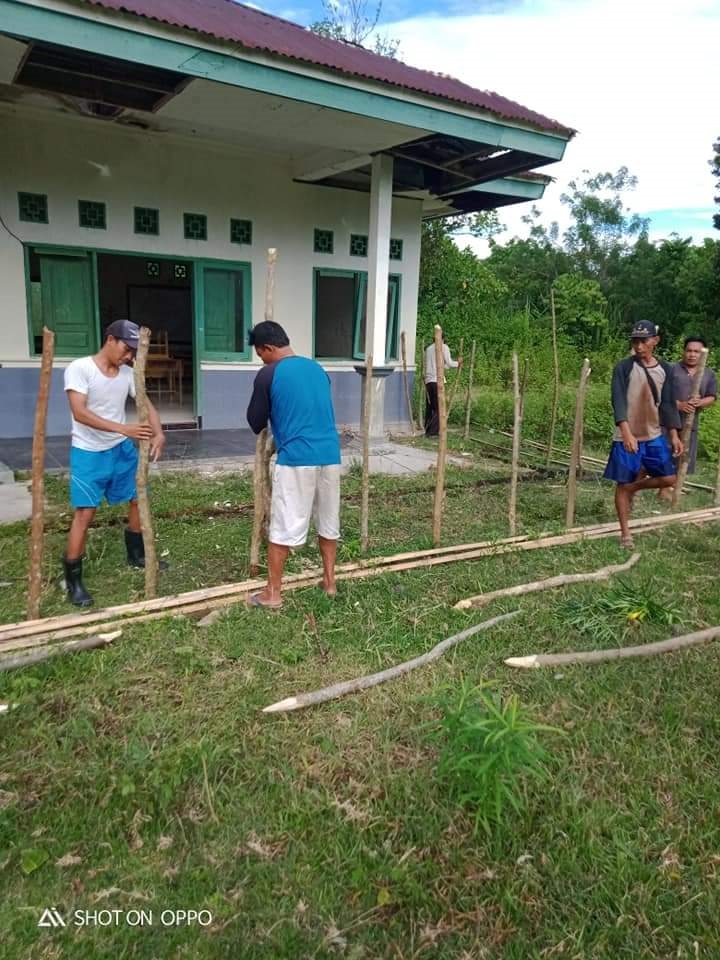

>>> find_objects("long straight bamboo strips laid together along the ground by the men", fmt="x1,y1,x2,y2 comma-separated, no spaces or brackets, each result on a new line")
5,507,720,653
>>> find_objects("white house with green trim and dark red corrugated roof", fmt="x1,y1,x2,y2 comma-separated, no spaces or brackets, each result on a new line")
0,0,573,437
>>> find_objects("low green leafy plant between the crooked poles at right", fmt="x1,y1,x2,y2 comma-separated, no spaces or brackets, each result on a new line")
557,583,682,644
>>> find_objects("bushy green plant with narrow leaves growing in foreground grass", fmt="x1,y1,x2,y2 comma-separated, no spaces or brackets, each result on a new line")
432,683,562,834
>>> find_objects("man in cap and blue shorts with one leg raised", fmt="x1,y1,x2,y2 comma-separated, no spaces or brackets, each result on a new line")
604,320,682,548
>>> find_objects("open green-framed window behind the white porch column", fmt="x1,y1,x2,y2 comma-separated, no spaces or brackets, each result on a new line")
314,269,400,363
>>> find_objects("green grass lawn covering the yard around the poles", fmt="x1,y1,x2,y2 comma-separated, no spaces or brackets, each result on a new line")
0,440,720,960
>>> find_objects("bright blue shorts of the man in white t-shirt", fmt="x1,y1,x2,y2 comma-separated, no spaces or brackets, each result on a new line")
70,439,138,509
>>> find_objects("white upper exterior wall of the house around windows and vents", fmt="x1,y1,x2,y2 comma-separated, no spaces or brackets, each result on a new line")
0,107,420,370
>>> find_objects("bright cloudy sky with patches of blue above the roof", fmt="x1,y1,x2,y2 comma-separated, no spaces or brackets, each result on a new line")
257,0,720,253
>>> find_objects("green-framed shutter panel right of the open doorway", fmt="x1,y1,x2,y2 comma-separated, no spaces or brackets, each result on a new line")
194,260,252,361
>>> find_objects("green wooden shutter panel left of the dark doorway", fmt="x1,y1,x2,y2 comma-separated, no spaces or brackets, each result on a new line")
27,249,98,357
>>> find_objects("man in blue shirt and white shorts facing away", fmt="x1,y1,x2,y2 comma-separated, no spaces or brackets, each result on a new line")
247,320,340,608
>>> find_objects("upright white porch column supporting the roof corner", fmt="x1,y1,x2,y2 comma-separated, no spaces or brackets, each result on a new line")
365,154,393,367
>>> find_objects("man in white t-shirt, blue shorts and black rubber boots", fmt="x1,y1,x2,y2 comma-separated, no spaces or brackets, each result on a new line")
63,320,165,607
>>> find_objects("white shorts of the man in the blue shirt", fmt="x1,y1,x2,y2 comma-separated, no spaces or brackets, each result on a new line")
268,463,340,547
